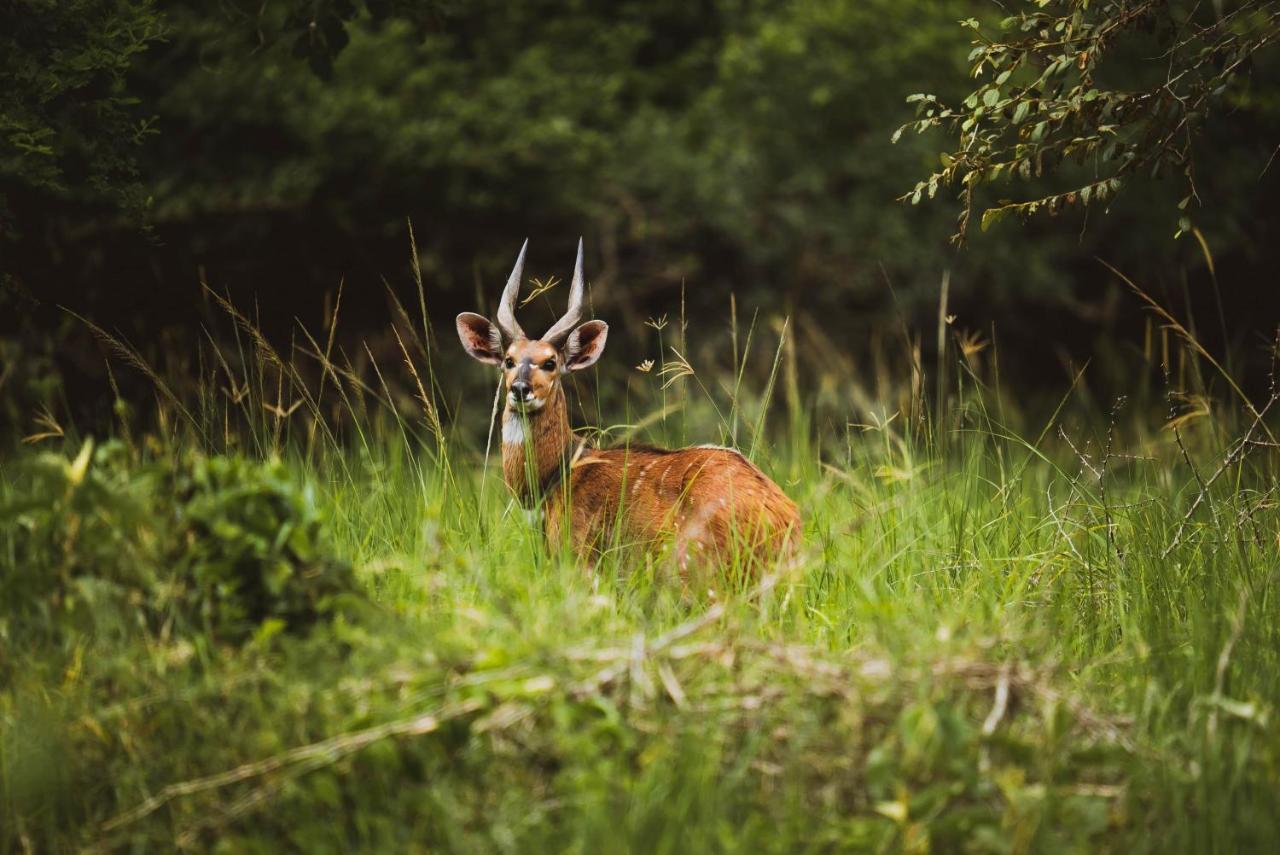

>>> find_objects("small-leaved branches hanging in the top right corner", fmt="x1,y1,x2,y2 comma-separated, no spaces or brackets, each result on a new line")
895,0,1280,241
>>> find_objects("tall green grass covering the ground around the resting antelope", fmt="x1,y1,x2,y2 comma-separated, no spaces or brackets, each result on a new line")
0,272,1280,852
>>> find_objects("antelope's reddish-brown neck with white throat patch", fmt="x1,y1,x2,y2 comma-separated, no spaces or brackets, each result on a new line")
502,385,573,504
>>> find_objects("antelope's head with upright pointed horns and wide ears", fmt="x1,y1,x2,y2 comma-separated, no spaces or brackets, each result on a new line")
457,238,609,413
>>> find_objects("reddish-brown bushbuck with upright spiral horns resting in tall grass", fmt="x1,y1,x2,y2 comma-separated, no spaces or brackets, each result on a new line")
457,239,800,575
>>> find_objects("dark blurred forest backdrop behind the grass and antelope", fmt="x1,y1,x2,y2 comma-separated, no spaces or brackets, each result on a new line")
0,0,1280,430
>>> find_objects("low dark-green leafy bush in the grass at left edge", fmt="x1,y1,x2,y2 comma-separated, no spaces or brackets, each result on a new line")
0,442,356,676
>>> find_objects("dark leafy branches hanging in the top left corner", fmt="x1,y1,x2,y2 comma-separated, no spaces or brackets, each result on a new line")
0,0,445,220
